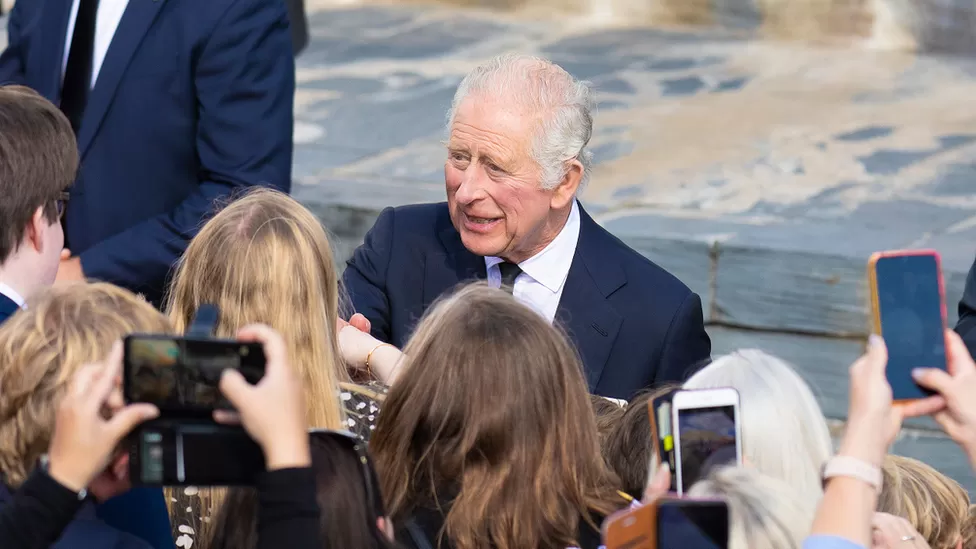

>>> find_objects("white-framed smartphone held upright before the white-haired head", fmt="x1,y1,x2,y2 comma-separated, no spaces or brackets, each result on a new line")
671,388,742,495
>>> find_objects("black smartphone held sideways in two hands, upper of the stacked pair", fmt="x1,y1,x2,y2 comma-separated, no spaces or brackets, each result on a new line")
122,334,265,417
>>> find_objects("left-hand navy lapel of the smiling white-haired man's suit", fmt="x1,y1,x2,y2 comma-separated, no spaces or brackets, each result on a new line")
423,225,488,311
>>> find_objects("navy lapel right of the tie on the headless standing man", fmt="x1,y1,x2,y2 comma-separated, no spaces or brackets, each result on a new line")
78,0,166,157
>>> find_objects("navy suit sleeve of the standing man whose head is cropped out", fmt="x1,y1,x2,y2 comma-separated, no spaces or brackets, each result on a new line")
80,0,295,289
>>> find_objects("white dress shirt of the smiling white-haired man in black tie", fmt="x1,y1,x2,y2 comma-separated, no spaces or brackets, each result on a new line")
485,201,580,322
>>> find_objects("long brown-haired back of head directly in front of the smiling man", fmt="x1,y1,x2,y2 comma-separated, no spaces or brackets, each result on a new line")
370,284,624,549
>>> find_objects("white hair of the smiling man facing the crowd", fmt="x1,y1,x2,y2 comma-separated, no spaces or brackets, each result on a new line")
447,54,593,191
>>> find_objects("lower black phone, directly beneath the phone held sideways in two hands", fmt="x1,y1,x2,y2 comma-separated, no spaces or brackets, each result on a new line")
129,419,265,486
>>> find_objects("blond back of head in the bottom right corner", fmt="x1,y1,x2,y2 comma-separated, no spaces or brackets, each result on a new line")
878,455,970,549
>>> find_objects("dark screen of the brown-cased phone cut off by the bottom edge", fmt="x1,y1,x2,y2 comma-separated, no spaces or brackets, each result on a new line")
657,500,729,549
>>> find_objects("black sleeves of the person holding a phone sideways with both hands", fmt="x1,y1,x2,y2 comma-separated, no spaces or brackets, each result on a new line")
0,467,324,549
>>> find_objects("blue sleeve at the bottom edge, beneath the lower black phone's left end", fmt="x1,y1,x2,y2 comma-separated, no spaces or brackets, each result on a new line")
97,488,175,549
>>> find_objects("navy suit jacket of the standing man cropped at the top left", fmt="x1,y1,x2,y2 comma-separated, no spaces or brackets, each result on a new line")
0,0,295,302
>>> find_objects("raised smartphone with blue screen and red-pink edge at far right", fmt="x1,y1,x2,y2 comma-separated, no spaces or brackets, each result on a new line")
868,250,946,403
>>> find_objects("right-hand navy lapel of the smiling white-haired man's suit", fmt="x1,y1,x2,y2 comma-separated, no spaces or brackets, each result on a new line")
556,207,627,392
